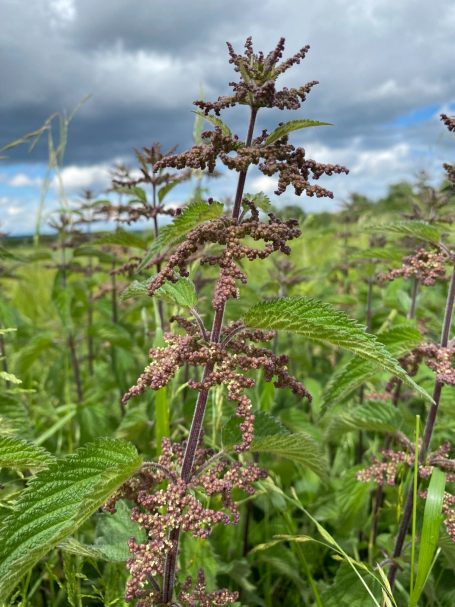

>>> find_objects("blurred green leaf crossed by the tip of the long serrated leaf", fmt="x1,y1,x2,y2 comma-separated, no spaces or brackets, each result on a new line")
322,325,422,409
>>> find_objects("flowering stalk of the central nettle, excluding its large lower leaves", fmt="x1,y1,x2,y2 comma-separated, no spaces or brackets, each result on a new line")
108,38,348,607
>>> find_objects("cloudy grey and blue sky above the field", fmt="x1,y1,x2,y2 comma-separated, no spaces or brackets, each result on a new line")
0,0,455,234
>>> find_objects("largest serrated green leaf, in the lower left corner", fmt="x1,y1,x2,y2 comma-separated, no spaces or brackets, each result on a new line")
0,439,141,599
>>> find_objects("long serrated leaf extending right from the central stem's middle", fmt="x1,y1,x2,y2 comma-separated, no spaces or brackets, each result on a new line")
244,297,432,401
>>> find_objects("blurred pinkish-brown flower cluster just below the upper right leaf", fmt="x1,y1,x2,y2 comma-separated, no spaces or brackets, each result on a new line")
379,249,449,286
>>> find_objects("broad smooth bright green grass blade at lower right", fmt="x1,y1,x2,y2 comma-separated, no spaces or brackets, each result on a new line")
409,468,446,607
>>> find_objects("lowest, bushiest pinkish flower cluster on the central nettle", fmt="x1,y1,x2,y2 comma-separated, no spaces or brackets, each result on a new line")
105,439,267,607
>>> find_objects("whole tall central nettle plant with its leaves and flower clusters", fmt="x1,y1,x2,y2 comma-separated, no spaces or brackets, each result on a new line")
0,38,429,607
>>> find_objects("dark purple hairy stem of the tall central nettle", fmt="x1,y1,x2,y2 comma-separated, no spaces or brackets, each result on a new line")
162,108,257,604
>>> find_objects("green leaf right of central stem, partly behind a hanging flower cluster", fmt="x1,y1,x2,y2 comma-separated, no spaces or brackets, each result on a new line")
223,411,328,477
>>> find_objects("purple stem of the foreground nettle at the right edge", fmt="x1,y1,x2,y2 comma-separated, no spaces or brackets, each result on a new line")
388,266,455,589
